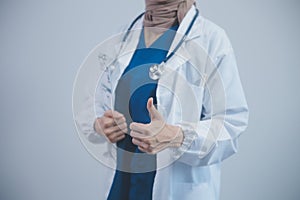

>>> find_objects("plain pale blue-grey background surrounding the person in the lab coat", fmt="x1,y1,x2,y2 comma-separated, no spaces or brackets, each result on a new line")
0,0,300,200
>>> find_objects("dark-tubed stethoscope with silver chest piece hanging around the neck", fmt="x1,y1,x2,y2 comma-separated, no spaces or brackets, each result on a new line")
122,8,199,80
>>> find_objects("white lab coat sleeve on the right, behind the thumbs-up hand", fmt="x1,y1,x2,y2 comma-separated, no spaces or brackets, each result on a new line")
175,34,248,166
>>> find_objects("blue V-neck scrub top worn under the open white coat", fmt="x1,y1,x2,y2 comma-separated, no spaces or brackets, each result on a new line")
108,25,178,200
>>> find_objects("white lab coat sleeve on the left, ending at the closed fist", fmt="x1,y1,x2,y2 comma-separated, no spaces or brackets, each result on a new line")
75,27,125,144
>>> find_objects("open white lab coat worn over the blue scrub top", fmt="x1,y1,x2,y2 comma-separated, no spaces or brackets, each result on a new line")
74,6,248,200
